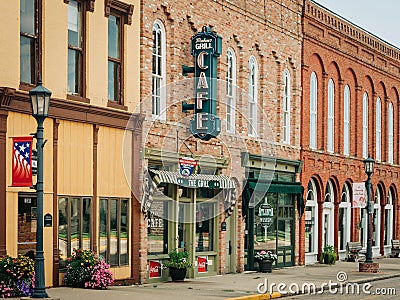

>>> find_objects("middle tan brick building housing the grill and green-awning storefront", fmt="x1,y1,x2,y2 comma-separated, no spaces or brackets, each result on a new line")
137,0,303,281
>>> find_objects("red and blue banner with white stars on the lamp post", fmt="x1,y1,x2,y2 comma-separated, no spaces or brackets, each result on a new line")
12,136,33,186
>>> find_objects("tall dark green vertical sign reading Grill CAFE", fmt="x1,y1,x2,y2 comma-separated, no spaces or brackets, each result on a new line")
190,27,222,141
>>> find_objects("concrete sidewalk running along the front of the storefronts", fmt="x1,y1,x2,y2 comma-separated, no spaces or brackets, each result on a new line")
41,258,400,300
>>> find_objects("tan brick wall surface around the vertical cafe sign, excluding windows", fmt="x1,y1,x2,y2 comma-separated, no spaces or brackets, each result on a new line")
140,0,303,273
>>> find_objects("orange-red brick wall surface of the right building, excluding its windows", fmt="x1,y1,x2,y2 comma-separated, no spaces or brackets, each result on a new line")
300,1,400,262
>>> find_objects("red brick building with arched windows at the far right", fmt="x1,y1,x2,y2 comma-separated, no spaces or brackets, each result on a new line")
300,1,400,264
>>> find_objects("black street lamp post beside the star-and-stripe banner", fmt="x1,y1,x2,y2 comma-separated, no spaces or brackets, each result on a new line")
29,79,51,298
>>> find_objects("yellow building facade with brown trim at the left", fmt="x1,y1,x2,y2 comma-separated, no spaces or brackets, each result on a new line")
0,0,142,286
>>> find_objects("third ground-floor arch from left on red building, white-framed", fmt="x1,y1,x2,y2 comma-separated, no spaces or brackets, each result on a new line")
338,183,351,259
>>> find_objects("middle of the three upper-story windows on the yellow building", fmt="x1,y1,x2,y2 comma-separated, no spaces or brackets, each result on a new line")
68,0,84,96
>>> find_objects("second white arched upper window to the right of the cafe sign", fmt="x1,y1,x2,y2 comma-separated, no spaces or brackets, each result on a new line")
248,56,258,136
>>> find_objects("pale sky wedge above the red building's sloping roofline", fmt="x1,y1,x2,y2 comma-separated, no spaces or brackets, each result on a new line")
314,0,400,48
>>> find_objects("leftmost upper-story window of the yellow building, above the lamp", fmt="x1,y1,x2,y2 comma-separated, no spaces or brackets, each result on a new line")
20,0,41,85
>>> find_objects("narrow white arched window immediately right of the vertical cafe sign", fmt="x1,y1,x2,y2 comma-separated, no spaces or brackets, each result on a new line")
226,49,236,133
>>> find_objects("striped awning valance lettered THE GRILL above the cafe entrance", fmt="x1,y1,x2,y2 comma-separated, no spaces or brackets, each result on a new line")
150,170,235,189
